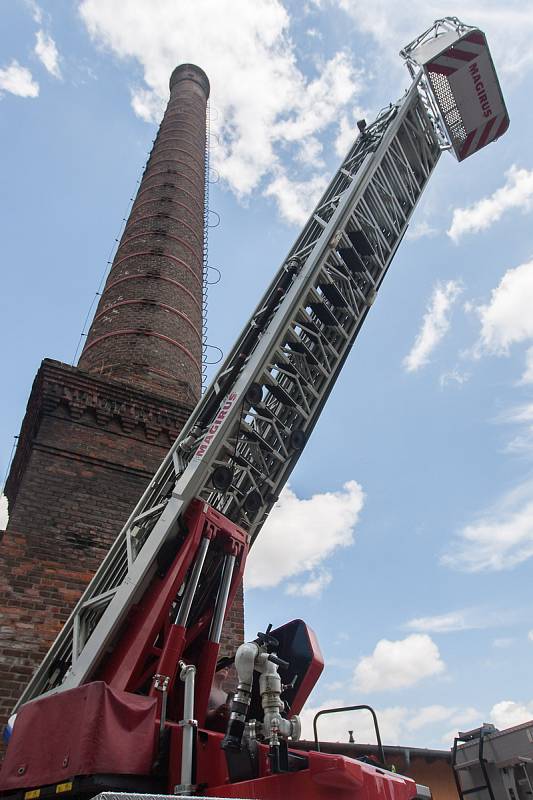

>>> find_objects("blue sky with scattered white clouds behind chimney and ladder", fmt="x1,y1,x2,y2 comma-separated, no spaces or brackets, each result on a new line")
0,0,533,747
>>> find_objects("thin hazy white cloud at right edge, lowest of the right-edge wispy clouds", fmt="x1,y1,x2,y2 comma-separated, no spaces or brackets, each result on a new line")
442,481,533,572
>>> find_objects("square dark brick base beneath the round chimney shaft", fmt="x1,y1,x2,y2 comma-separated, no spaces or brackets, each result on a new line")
0,360,243,723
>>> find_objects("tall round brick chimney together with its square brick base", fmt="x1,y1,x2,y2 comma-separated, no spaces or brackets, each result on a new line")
0,64,244,726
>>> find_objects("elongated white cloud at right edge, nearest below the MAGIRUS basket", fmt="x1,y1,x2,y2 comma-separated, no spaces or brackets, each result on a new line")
448,165,533,242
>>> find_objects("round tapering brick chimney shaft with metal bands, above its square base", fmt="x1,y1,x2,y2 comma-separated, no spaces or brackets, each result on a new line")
78,64,209,402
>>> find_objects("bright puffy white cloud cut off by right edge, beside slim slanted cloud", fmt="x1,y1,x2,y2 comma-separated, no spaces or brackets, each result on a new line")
477,260,533,355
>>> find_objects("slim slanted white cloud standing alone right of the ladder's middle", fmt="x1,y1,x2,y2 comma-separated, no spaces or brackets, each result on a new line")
403,281,462,372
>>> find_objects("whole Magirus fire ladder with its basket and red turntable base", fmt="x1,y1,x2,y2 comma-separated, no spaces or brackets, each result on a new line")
0,17,509,800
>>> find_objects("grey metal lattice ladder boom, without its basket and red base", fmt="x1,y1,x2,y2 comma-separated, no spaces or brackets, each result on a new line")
19,81,441,703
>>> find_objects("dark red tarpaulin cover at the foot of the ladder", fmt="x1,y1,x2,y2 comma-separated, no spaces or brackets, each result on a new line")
0,681,156,789
